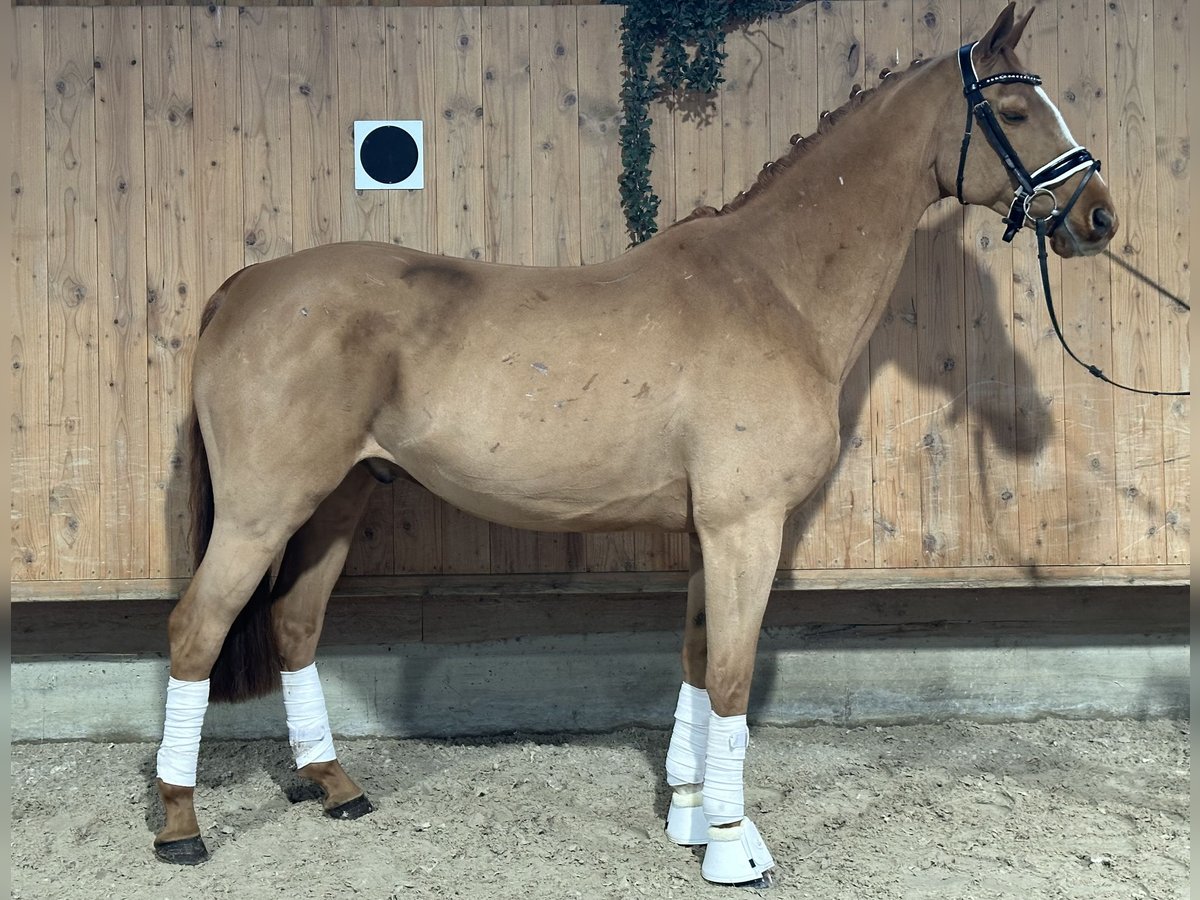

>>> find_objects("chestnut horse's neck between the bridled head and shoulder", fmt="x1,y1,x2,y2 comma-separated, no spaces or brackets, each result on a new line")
724,60,961,385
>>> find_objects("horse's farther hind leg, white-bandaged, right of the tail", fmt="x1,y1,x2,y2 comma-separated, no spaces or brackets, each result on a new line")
271,464,377,818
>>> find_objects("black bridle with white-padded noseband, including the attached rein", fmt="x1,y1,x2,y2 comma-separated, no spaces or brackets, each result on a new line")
955,43,1192,397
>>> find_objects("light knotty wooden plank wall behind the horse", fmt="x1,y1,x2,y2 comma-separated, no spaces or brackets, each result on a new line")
11,0,1190,592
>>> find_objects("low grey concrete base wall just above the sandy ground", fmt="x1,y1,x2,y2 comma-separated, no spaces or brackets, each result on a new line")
12,628,1189,740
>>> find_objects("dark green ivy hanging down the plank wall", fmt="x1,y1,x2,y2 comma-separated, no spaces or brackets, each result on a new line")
605,0,811,246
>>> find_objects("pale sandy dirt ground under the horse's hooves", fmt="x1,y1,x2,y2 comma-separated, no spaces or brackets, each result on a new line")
12,720,1190,900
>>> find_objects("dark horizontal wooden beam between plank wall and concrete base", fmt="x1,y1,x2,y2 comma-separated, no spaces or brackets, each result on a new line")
11,586,1188,658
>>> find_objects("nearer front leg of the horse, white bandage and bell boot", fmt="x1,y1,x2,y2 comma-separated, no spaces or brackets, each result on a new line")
698,512,784,884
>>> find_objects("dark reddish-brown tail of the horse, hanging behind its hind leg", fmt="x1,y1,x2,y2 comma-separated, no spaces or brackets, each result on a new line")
188,269,280,703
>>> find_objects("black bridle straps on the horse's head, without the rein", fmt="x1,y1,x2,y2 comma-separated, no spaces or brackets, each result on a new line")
955,43,1100,241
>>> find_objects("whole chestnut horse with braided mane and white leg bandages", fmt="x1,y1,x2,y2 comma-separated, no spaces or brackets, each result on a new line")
155,4,1117,883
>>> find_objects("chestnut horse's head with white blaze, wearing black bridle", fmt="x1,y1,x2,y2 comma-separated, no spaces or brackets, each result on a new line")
937,2,1117,257
